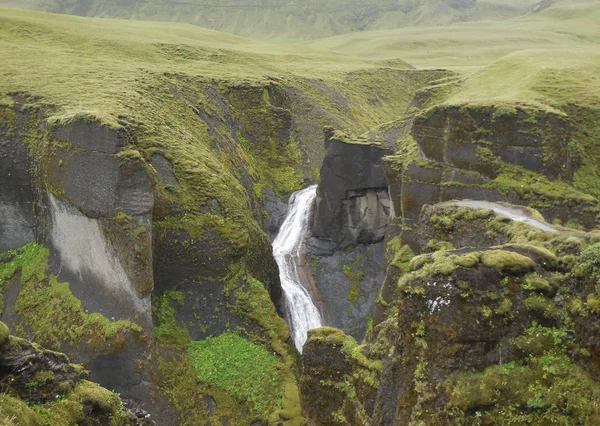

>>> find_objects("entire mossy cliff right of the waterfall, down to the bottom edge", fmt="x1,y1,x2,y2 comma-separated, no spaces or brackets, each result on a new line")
300,62,600,425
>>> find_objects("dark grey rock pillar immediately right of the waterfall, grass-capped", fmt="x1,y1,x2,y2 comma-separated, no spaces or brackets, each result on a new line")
308,128,392,339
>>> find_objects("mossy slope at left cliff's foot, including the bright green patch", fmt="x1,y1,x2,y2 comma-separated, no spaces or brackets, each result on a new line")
152,274,305,426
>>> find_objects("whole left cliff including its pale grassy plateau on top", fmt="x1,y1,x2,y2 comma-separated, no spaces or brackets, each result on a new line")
0,10,454,425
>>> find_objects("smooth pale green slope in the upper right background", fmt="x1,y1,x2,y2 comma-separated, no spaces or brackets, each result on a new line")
302,0,600,69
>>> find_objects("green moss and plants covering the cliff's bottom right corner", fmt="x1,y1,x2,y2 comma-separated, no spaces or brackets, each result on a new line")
446,324,600,425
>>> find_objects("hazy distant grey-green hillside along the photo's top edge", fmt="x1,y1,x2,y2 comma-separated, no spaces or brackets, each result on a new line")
0,0,538,41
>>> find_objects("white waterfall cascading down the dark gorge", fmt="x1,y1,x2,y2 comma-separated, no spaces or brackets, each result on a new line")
273,185,321,352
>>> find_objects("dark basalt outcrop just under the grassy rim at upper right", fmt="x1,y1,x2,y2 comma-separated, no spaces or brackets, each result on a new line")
411,106,575,180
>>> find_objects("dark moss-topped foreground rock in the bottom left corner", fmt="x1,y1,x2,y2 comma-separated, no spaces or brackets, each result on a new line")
0,323,155,426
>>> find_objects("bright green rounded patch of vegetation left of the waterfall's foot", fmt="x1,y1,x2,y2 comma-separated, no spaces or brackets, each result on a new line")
188,333,283,419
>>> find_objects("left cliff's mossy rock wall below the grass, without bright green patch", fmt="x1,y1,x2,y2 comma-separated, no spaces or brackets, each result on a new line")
0,81,317,425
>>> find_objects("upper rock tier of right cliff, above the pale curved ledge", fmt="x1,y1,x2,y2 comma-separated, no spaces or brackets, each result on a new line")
384,105,598,228
